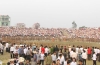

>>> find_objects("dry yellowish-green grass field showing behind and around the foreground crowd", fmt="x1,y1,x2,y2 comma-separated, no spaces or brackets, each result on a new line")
0,41,100,65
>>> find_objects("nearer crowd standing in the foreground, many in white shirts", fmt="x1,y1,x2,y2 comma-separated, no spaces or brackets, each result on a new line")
0,43,100,65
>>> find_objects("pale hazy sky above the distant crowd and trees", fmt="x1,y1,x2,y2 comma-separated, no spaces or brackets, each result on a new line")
0,0,100,28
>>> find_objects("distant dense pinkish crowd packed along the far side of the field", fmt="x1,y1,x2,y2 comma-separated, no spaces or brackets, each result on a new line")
0,27,100,39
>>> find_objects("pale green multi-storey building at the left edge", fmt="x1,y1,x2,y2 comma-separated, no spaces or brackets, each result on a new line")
0,15,10,26
